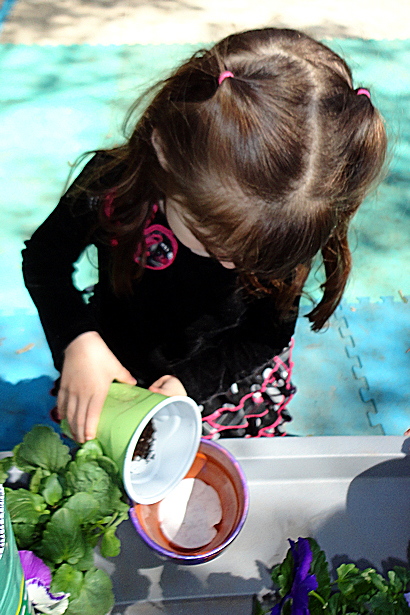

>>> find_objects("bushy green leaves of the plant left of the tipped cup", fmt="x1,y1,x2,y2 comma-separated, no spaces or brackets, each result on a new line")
0,425,129,615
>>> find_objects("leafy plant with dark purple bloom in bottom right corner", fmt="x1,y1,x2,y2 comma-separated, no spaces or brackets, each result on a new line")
256,538,410,615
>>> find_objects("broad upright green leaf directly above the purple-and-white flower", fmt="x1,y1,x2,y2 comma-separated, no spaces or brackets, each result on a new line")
41,508,86,564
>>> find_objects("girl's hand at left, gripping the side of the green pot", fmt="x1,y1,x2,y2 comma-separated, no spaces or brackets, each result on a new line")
57,331,137,442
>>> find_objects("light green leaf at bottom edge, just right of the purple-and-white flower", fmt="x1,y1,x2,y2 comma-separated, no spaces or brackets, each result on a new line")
65,568,114,615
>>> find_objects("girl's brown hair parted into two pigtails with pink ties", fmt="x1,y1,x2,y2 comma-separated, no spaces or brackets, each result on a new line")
77,28,386,330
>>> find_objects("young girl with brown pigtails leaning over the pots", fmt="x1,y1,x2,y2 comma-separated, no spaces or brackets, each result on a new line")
23,28,386,442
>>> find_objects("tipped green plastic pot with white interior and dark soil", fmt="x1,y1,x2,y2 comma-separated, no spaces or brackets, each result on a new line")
96,383,202,504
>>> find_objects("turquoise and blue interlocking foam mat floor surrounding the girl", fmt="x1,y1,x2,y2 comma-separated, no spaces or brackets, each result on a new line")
0,39,410,450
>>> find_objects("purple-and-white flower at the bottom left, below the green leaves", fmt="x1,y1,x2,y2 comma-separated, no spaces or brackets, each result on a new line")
19,551,70,615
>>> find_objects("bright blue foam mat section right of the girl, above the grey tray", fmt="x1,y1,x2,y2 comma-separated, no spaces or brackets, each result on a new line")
289,295,410,435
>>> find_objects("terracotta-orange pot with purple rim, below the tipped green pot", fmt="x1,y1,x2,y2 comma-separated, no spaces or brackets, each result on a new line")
130,439,249,564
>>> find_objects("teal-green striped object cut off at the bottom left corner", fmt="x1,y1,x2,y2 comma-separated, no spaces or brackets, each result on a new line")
0,485,33,615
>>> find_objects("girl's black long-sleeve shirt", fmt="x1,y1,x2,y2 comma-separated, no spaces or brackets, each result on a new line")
23,161,296,403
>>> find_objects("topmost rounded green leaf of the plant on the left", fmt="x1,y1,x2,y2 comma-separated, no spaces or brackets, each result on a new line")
15,425,70,472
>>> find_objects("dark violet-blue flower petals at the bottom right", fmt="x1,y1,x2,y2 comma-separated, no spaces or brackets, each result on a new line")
271,538,318,615
